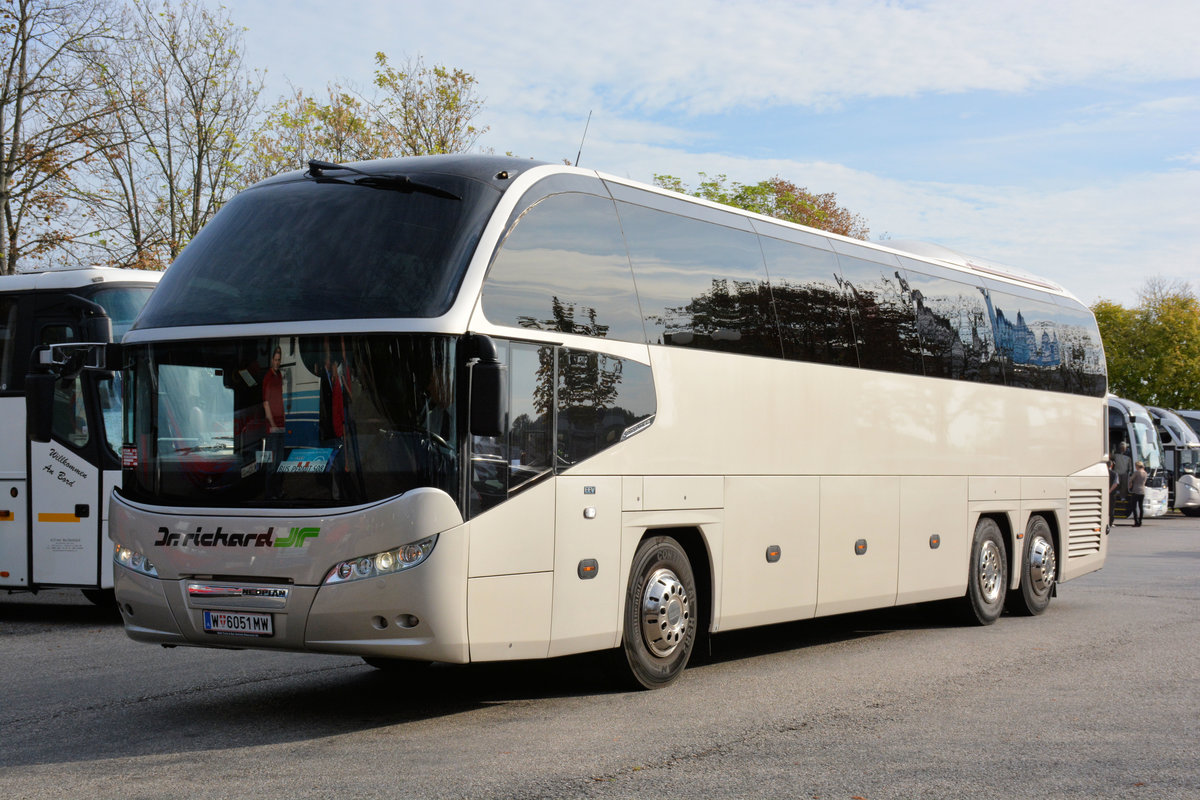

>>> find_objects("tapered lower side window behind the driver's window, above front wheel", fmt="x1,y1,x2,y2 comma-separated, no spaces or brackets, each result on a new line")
557,349,655,469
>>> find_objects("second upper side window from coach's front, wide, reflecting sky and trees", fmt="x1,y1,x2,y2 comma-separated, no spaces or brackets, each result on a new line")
617,203,782,357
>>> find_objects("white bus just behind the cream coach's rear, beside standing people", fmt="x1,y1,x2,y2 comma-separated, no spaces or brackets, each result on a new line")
1109,395,1169,518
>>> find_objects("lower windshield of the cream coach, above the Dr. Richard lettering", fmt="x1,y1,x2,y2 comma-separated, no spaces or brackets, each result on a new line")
121,335,458,507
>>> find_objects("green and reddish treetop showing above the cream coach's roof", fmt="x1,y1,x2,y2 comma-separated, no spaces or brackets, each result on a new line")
654,173,870,240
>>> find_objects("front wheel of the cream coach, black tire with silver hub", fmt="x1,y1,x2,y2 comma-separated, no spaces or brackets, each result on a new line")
622,536,697,688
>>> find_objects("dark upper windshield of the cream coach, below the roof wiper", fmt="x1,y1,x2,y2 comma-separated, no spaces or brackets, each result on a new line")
137,174,499,329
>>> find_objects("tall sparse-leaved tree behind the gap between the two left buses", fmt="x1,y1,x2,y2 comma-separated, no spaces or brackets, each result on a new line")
81,0,262,269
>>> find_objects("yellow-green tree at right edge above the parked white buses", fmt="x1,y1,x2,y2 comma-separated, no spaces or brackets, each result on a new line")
1092,278,1200,409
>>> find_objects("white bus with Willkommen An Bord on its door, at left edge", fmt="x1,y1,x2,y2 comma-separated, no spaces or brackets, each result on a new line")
0,269,160,601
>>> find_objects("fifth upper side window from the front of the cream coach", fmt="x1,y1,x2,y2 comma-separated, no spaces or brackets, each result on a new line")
905,270,1004,384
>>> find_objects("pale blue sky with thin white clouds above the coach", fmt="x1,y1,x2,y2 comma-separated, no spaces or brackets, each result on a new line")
232,0,1200,306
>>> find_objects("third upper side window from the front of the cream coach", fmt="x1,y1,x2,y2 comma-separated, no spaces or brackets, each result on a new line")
760,236,858,367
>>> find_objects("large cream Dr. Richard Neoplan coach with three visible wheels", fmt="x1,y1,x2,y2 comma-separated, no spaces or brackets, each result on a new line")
93,156,1106,687
